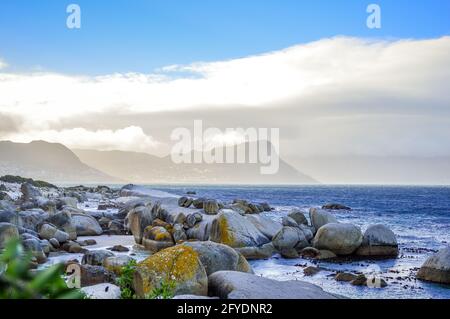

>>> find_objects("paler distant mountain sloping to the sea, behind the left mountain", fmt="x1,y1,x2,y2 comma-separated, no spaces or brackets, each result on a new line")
73,145,317,184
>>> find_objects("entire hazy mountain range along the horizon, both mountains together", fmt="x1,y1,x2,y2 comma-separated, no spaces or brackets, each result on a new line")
0,141,317,184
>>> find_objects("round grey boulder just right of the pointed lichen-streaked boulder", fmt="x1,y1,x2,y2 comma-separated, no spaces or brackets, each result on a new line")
272,226,309,257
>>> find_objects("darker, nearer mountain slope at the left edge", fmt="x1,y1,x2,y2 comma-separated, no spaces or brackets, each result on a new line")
0,141,120,183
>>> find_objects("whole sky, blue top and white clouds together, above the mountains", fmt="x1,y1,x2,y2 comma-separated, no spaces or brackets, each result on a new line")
0,0,450,180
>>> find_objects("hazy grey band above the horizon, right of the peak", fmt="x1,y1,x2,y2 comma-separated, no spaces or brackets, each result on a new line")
290,156,450,185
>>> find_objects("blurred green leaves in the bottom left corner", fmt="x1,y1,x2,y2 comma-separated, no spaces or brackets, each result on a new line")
0,239,84,299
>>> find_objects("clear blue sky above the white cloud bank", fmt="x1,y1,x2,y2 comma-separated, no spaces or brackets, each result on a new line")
0,0,450,74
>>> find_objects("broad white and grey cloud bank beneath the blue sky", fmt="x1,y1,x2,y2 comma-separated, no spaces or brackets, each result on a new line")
0,37,450,156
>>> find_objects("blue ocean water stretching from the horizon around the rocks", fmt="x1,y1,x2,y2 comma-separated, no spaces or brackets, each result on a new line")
145,185,450,299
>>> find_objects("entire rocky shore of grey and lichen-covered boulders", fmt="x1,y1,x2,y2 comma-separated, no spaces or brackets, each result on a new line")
0,177,450,299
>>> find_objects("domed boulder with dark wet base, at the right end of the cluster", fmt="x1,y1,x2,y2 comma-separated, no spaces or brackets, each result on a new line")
356,224,398,257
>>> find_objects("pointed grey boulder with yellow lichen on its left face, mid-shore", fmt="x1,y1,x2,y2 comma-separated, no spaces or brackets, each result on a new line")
210,209,270,248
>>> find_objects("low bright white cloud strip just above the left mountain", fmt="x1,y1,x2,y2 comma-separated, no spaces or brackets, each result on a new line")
3,126,160,153
